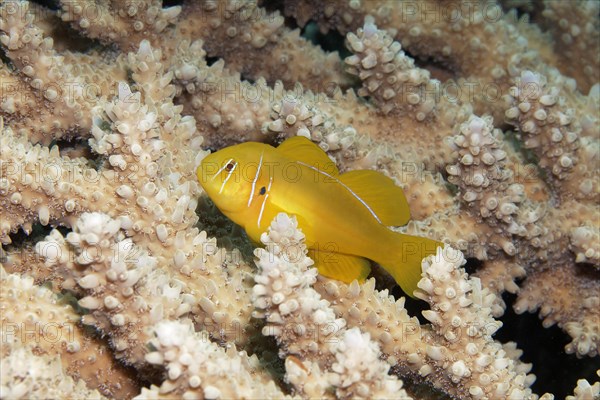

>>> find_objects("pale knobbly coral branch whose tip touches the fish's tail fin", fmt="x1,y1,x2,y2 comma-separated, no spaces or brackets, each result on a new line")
418,247,535,399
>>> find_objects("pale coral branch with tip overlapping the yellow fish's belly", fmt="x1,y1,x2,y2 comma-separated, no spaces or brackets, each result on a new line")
253,213,410,399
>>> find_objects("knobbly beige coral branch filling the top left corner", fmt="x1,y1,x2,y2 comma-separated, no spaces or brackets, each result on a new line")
0,1,125,145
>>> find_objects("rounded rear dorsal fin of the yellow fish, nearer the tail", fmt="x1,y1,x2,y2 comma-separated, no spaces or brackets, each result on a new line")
339,170,410,226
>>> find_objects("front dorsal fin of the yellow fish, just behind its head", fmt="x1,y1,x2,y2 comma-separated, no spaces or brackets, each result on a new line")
276,136,340,176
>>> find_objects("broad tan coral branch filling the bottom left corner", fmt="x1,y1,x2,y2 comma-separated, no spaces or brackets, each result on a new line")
0,266,139,398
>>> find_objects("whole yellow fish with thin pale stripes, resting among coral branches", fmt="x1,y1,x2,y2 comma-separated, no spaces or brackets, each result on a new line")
196,136,442,296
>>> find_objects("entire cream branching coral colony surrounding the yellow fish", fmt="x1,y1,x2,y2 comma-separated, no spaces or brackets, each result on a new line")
0,0,600,399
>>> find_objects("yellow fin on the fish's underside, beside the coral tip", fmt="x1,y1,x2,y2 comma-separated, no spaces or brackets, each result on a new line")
308,250,371,283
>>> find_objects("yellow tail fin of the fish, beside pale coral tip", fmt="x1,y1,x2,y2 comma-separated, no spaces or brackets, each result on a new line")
379,232,444,298
